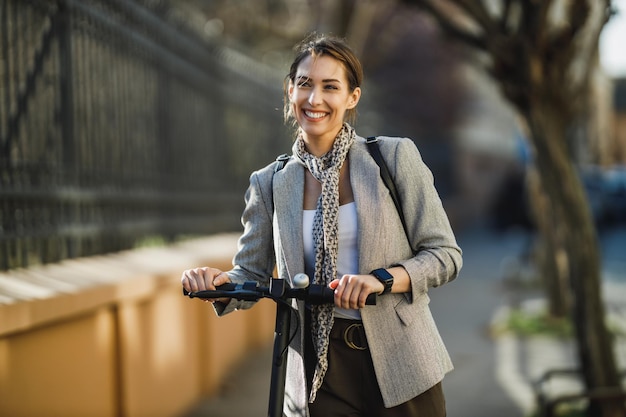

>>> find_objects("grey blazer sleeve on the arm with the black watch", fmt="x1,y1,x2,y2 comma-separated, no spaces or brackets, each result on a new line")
385,138,463,300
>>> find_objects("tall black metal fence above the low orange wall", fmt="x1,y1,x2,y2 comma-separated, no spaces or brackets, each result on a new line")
0,0,290,269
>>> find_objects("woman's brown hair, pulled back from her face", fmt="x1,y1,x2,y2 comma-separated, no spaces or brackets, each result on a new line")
283,32,363,124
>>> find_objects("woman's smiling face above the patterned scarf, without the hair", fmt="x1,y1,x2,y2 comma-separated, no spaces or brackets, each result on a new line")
289,55,361,152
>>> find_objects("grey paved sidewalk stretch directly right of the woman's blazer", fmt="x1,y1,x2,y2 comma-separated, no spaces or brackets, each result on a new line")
430,231,527,417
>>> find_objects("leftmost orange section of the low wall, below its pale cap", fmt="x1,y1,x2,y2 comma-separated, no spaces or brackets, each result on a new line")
0,308,118,417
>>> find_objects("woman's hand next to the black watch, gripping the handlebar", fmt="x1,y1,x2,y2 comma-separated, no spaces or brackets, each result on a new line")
328,275,385,309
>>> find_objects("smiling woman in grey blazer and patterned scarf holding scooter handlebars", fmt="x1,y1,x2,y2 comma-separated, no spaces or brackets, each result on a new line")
181,35,462,417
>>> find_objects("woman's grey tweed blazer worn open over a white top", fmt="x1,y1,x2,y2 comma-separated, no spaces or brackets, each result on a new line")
216,137,462,416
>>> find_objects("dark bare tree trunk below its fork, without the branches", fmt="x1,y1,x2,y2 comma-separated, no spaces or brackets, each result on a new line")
527,103,626,417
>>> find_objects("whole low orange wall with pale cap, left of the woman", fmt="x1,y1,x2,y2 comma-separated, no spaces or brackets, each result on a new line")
0,235,275,417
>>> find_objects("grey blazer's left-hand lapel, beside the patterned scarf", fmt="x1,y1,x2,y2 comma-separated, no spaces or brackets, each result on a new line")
273,159,304,277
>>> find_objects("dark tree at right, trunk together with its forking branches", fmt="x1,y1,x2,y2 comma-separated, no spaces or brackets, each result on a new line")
394,0,626,417
